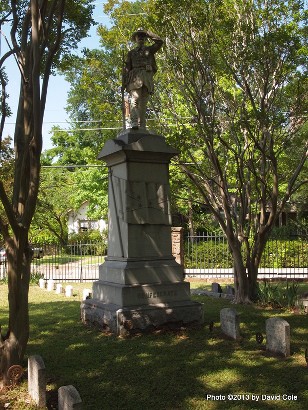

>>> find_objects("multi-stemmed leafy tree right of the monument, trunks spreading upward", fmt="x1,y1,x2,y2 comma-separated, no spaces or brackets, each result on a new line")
149,0,307,303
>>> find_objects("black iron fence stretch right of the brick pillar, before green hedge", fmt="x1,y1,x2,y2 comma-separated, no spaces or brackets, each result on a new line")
185,233,308,278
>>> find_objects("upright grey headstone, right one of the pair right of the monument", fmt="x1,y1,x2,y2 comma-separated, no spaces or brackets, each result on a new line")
265,317,290,357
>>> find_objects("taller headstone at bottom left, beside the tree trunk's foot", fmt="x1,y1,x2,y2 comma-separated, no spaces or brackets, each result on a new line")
28,355,46,408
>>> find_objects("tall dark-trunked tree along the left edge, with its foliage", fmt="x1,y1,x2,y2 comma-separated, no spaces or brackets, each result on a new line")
0,0,92,382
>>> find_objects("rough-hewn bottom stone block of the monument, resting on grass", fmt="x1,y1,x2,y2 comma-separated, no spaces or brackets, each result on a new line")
81,299,203,336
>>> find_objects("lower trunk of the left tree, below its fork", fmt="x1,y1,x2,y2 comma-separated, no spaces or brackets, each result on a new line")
0,235,32,384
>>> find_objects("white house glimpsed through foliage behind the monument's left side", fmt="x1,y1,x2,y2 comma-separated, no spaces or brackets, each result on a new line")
68,201,107,235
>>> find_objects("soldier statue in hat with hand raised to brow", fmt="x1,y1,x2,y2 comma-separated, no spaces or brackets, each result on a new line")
123,28,163,129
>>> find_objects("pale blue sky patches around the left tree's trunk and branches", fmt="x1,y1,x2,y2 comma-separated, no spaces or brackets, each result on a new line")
1,0,110,150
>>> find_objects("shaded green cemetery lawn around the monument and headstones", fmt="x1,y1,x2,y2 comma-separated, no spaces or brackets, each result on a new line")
0,282,308,410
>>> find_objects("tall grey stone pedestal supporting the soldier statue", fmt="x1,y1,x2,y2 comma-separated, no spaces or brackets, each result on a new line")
81,29,203,335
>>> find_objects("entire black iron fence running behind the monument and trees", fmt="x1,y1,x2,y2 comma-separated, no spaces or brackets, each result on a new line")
0,233,308,282
